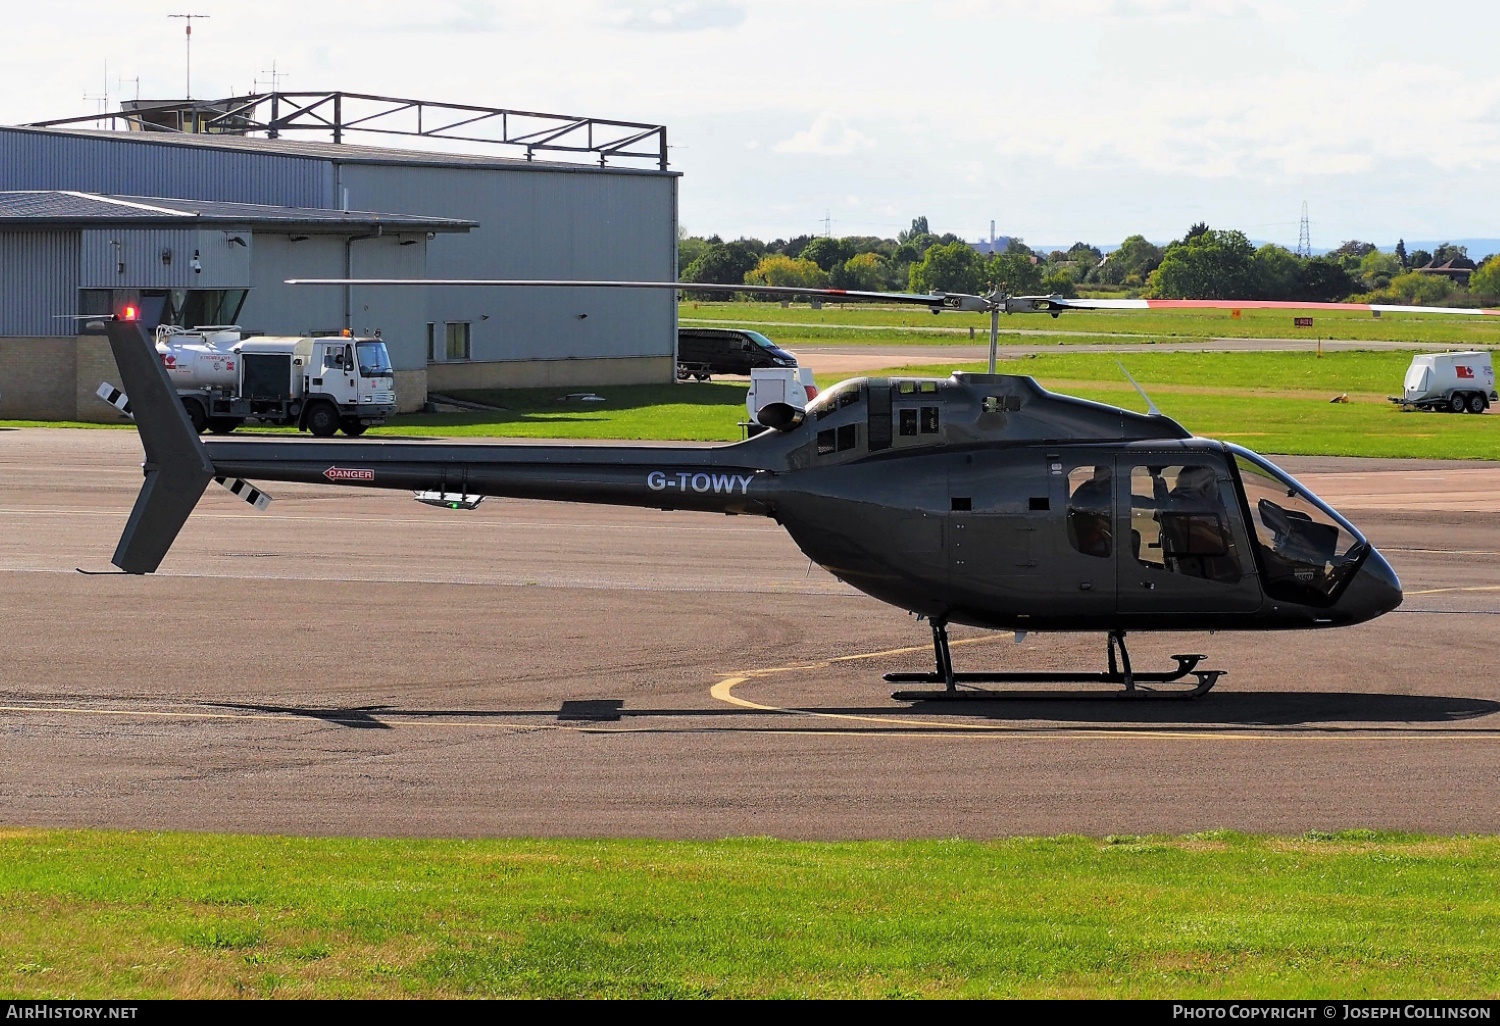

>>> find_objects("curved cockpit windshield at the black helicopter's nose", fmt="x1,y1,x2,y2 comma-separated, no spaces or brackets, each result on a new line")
1229,446,1370,605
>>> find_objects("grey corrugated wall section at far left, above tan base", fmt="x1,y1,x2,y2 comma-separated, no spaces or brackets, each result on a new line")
0,231,78,336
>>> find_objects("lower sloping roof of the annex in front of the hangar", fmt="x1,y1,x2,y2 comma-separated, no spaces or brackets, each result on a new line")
0,189,479,234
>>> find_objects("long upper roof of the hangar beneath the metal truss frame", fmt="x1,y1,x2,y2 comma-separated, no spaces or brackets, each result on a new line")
0,125,683,177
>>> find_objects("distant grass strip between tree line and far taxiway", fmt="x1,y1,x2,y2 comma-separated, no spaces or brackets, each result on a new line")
678,302,1500,347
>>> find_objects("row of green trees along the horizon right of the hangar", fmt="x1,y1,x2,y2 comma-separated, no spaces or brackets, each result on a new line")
678,218,1500,306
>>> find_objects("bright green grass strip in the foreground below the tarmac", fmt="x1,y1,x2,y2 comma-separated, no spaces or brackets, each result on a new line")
0,831,1500,999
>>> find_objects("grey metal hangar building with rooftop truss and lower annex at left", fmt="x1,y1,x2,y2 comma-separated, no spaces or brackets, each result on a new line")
0,93,680,419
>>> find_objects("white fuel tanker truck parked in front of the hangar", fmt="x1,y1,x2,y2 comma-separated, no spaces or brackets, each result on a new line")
156,326,396,438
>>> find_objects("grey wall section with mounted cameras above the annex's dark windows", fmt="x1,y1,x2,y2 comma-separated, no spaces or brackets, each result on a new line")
78,228,254,288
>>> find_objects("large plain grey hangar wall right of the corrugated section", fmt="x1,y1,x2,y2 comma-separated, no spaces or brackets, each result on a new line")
342,165,677,360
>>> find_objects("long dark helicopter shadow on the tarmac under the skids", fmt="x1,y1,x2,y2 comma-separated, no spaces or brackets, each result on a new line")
202,692,1500,735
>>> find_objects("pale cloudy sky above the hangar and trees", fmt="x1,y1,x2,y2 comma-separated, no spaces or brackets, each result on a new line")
0,0,1500,249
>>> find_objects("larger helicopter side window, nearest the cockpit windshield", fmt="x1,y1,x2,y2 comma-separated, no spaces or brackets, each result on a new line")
1130,464,1242,584
